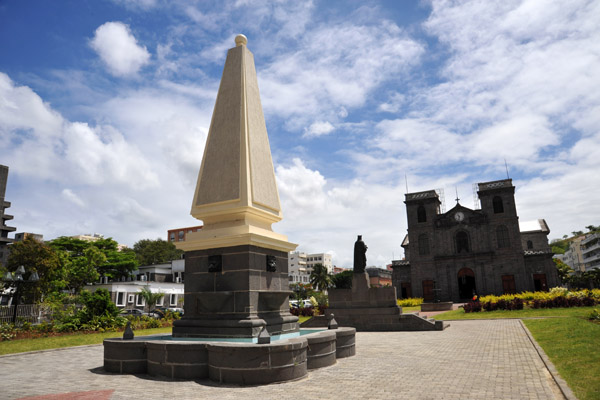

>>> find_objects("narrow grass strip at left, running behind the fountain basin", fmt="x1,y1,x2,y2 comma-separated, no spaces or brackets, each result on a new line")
0,327,173,355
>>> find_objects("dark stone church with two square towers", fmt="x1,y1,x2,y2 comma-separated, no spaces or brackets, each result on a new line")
392,179,559,302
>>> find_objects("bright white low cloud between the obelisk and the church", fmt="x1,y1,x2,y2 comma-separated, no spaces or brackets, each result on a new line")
273,158,405,267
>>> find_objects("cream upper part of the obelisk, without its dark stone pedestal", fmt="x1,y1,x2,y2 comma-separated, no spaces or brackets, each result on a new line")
177,35,297,252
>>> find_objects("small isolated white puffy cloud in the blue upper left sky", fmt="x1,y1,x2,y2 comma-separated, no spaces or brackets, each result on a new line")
90,22,150,76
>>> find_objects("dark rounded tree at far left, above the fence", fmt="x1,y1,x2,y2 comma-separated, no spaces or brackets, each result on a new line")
6,237,67,302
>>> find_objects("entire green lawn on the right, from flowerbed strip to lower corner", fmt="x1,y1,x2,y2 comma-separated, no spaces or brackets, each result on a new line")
434,306,600,400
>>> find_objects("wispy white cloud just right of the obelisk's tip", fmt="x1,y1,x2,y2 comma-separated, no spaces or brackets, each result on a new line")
258,21,424,129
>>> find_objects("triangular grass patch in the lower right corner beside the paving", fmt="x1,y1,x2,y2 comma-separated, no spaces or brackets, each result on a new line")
523,317,600,400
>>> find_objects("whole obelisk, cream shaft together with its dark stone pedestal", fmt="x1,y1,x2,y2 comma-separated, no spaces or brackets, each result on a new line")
173,35,298,337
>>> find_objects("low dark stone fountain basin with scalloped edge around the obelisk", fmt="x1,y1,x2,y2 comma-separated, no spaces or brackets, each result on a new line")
104,328,356,385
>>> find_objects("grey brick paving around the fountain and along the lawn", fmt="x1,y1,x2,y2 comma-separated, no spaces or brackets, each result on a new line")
0,320,564,400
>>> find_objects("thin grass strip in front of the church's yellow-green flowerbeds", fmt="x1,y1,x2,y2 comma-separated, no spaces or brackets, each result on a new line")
433,306,598,321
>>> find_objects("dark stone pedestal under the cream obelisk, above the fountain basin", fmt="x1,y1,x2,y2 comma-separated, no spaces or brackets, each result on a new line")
173,245,299,337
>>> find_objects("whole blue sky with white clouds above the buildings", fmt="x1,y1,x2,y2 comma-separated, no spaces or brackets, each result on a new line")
0,0,600,267
